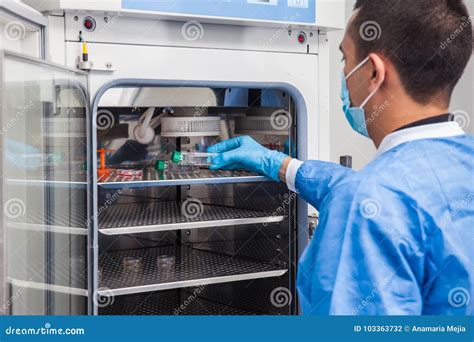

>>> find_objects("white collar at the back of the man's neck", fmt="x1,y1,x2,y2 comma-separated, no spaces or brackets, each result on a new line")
377,121,465,156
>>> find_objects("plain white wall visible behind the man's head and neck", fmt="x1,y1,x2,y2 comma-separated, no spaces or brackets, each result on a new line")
328,0,474,169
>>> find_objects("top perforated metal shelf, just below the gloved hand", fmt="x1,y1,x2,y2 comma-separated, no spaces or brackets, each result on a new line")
98,167,269,188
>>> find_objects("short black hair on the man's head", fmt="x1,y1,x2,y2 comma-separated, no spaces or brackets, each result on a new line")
350,0,474,104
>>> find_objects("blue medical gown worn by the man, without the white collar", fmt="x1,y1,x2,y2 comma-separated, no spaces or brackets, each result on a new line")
296,135,474,315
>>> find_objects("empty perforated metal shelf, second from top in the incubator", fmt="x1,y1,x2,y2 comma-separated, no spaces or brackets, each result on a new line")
99,201,284,235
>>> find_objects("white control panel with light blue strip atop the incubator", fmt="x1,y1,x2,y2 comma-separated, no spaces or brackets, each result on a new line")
22,0,346,30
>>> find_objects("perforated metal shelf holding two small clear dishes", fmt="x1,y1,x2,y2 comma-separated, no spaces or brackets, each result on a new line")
98,246,288,296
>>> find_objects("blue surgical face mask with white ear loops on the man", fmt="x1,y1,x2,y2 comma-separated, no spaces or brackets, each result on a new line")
341,57,380,137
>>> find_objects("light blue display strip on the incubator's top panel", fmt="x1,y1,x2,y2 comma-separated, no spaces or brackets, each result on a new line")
122,0,316,24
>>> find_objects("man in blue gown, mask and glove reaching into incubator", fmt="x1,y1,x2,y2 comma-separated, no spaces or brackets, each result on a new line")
209,0,474,315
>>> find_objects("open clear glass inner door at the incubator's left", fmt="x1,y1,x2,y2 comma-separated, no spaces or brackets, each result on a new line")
1,54,88,315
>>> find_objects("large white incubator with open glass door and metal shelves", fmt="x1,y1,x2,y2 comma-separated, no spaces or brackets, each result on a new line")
0,0,344,315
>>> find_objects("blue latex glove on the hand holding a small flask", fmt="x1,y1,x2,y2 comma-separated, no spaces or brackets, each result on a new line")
207,136,287,182
